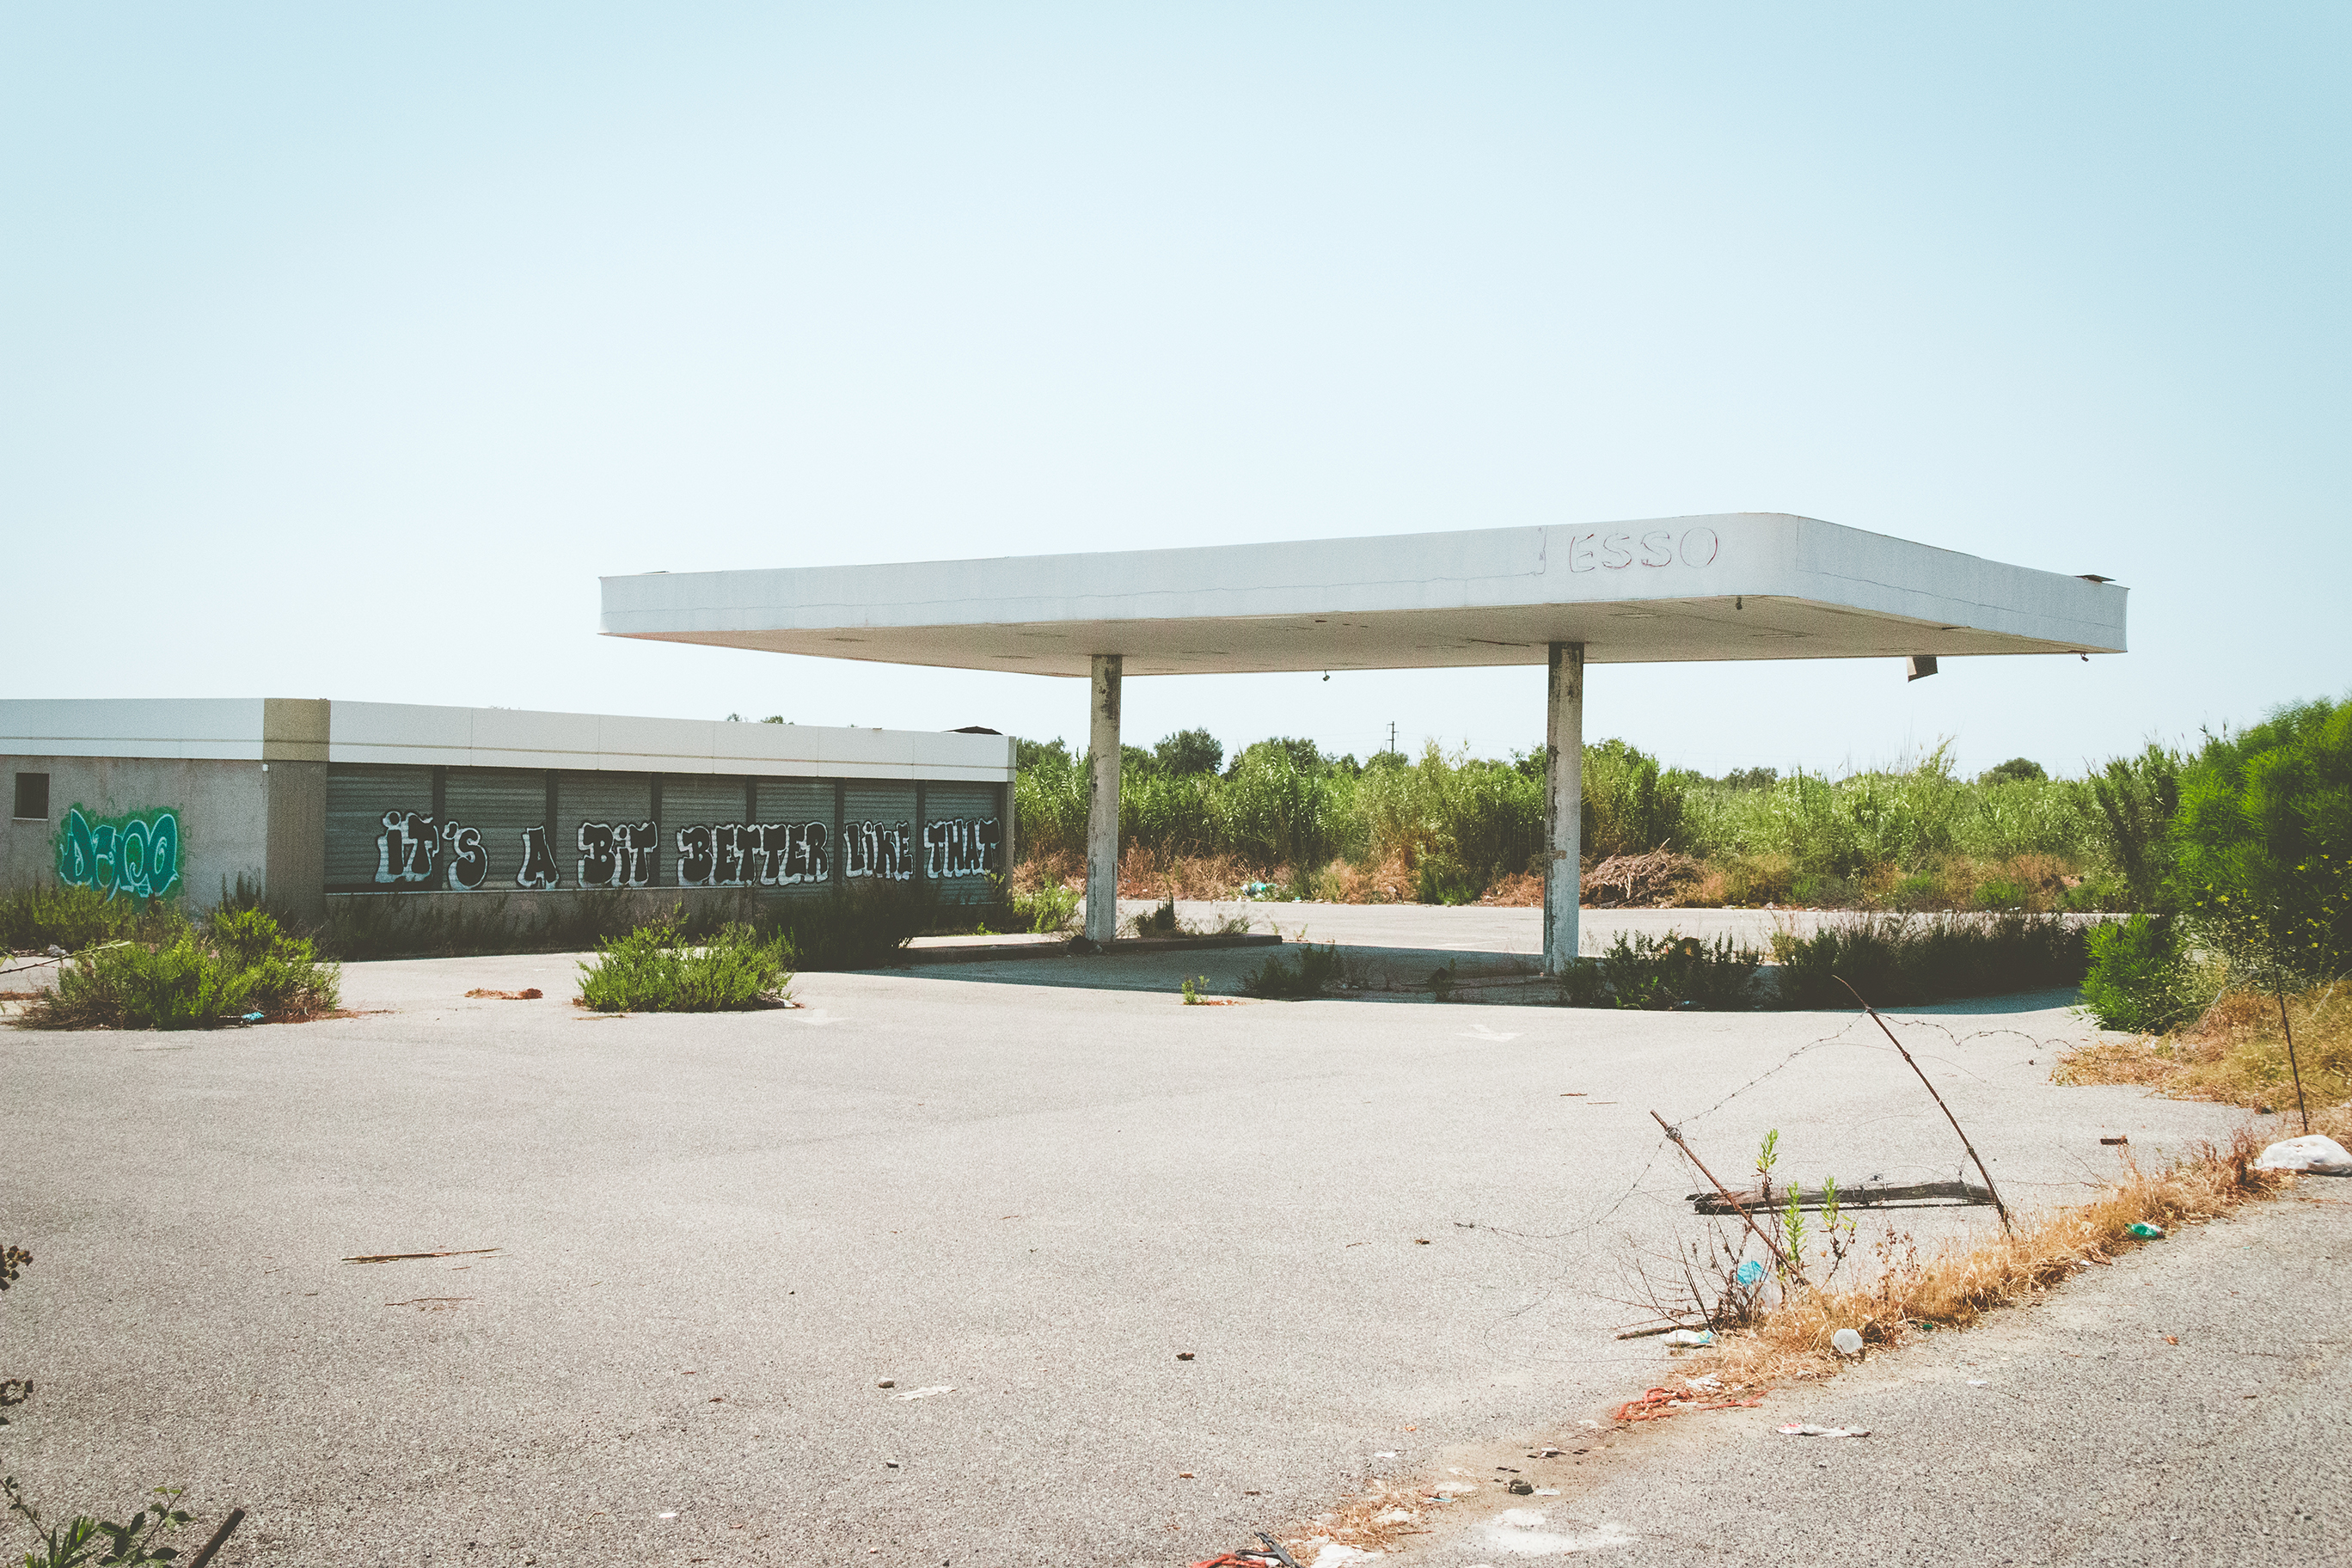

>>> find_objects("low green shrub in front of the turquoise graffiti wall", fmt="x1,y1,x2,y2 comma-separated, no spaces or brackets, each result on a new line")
26,910,341,1030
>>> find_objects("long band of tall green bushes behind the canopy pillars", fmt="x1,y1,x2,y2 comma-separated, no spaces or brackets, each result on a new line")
1014,731,2169,903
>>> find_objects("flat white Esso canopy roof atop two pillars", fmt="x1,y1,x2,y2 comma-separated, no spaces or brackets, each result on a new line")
602,512,2126,677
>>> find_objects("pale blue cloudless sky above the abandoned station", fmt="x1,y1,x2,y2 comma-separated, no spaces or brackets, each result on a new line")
0,3,2352,771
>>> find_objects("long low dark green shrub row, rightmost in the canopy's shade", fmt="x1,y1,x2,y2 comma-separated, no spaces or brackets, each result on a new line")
1771,912,2086,1008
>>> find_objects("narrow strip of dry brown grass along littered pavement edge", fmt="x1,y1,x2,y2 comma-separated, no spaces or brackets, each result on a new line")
1691,1129,2294,1387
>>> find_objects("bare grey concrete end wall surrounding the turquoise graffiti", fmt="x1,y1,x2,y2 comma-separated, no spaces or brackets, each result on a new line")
0,755,271,910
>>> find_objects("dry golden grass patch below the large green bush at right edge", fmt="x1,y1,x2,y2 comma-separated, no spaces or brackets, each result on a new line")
2051,983,2352,1142
